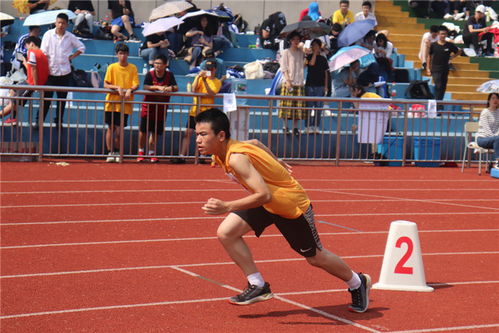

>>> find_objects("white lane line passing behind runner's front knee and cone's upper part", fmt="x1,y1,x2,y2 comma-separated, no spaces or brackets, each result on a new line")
0,229,499,250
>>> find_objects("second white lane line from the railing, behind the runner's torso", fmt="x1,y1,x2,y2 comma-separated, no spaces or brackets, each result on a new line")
1,187,499,195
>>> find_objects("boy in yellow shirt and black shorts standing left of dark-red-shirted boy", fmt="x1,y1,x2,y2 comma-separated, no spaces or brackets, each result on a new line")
104,43,139,163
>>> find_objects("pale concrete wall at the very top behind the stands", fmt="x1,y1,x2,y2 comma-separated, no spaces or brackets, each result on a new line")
0,0,366,30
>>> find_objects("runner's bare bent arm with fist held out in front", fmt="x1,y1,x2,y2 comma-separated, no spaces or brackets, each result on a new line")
202,154,272,215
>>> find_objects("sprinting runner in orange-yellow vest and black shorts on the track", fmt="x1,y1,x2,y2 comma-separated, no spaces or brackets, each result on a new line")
195,108,371,312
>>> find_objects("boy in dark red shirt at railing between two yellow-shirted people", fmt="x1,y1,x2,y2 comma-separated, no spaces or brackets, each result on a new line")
137,54,178,163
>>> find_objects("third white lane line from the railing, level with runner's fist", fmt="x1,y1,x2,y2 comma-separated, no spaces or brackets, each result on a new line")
1,198,499,209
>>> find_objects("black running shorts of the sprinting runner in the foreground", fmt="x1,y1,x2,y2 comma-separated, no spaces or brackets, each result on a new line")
233,206,322,257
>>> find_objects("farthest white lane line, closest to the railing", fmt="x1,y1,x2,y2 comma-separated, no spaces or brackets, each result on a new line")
0,178,490,184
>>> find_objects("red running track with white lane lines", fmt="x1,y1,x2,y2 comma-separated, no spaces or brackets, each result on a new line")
0,162,499,332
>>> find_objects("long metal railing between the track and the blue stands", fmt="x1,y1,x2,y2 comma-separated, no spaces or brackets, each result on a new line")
0,85,485,165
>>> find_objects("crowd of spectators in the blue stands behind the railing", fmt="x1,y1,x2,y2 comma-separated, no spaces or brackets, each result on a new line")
0,0,494,163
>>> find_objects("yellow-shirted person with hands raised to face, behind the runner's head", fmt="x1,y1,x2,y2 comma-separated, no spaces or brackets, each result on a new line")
176,60,222,164
